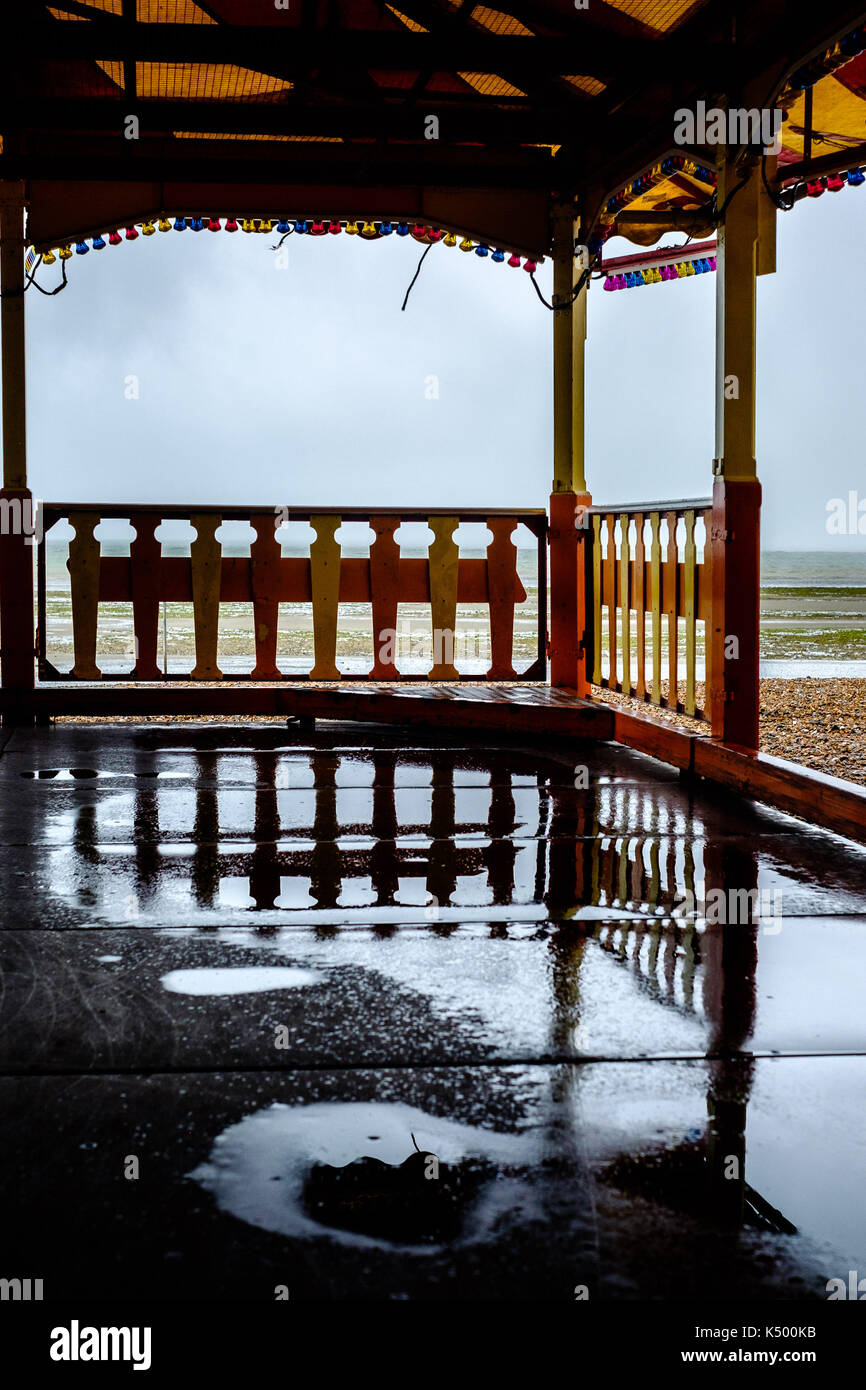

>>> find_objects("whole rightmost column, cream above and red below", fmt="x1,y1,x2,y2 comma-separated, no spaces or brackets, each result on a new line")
706,150,776,748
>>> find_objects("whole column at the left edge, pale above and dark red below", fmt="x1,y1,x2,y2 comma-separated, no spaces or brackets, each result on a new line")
0,182,35,723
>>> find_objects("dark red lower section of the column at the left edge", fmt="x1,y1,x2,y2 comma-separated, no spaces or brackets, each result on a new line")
0,488,35,723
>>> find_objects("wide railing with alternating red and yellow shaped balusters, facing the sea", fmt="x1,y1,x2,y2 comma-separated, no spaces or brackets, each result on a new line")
39,503,546,681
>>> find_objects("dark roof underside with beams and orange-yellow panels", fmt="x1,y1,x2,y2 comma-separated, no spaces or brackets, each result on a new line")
0,0,866,254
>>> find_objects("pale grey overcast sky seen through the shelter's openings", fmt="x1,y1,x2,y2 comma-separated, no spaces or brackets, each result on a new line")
26,189,866,550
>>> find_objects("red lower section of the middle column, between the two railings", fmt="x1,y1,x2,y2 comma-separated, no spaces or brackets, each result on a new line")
549,492,592,698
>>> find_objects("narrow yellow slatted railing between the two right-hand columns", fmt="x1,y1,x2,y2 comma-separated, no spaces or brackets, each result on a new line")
585,499,712,719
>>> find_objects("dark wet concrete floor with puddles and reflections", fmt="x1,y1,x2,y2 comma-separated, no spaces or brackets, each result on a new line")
0,724,866,1301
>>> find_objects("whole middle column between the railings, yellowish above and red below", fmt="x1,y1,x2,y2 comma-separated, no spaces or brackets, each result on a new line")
549,204,592,695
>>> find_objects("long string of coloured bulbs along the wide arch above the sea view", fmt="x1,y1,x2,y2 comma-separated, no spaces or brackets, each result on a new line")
42,217,541,274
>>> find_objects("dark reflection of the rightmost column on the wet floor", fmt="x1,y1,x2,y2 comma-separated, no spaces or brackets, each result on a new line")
702,842,758,1225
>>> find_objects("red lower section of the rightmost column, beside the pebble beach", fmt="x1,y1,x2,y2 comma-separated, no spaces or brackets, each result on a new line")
706,478,760,749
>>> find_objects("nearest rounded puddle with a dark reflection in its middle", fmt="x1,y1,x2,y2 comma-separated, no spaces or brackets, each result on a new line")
190,1101,538,1251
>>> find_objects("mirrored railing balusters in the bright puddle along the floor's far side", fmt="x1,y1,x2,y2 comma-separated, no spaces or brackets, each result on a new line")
57,749,712,930
